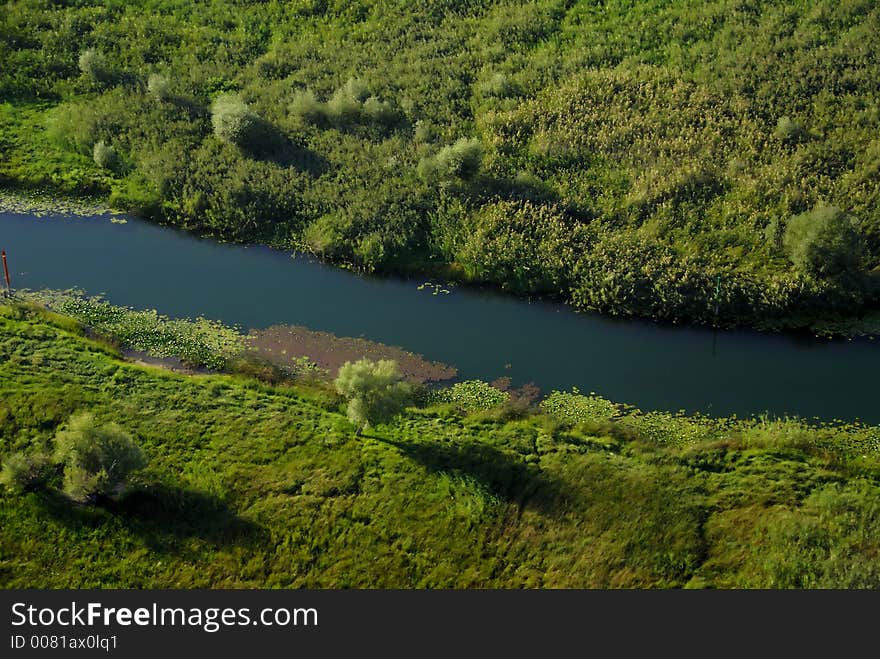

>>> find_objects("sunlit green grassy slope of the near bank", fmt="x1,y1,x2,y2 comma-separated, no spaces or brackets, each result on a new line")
0,305,880,588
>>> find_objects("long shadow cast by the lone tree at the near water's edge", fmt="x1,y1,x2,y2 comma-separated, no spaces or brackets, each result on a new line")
374,435,575,515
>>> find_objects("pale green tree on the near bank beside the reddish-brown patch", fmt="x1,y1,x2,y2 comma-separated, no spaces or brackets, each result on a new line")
335,358,412,435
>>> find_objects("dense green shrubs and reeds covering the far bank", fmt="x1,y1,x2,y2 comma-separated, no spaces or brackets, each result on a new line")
0,0,880,326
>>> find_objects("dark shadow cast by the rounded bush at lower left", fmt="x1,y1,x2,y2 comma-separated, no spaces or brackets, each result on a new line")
34,485,267,551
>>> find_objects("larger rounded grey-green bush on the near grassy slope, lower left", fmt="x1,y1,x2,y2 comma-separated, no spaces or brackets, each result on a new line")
55,413,146,502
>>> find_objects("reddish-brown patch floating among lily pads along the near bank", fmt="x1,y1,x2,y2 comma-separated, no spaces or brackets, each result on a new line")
248,325,458,382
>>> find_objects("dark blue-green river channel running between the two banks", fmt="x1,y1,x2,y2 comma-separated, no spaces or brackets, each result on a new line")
0,213,880,423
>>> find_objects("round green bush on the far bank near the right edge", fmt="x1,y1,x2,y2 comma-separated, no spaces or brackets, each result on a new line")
783,206,865,277
